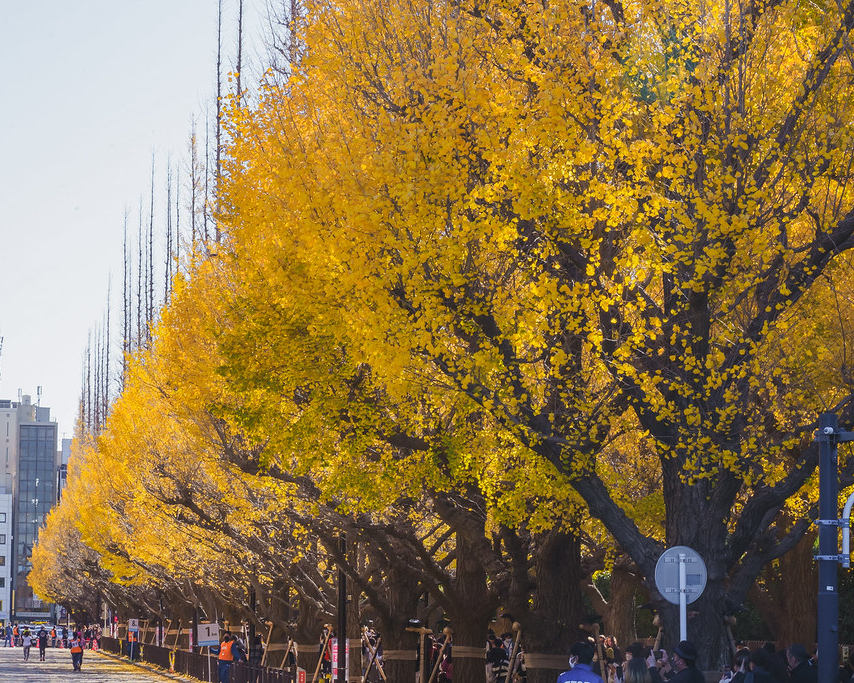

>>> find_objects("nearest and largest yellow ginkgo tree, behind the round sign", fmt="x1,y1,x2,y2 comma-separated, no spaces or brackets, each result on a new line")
222,0,854,666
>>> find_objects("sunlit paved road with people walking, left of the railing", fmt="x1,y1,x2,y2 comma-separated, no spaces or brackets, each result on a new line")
0,647,191,683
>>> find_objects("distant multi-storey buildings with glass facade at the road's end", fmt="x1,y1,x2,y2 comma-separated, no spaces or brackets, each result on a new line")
0,396,61,622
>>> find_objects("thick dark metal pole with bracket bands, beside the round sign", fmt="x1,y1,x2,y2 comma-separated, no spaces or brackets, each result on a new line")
818,413,839,681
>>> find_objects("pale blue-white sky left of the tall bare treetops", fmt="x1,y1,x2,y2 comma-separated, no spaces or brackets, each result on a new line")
0,0,264,437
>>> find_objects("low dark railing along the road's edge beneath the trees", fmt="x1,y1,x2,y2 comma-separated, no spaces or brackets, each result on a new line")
101,637,294,683
